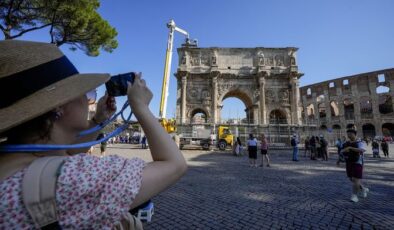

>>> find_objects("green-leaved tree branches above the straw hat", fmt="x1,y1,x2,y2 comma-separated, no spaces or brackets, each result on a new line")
0,0,118,56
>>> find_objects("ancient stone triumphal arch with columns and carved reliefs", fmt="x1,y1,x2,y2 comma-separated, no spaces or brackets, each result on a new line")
175,47,303,126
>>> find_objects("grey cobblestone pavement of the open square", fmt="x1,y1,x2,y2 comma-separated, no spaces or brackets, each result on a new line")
96,145,394,229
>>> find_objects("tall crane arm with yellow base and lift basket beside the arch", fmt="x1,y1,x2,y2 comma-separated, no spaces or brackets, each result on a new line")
159,19,197,133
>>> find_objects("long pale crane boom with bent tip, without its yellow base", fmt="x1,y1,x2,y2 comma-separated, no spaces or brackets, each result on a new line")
159,20,189,119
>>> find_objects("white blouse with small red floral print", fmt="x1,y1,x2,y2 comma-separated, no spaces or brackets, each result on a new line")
0,154,145,229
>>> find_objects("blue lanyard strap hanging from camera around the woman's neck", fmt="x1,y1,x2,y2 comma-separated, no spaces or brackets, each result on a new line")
0,101,133,152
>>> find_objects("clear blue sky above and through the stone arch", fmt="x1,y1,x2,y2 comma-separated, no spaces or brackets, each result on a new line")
3,0,394,120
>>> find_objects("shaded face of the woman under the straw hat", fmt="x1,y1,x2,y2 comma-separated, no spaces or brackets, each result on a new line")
58,95,89,132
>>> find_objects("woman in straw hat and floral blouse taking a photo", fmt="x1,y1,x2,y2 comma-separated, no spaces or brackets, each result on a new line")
0,40,187,229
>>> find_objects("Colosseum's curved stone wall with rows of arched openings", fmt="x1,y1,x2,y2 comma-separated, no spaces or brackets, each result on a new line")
300,68,394,138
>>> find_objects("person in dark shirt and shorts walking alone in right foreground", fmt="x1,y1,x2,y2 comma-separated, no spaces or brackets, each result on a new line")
342,129,369,202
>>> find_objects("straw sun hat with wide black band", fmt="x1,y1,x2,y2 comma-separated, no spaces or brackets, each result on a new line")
0,40,109,133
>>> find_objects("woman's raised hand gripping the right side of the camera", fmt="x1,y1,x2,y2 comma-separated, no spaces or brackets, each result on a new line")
127,73,153,114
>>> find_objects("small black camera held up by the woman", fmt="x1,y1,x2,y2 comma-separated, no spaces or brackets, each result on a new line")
105,72,135,97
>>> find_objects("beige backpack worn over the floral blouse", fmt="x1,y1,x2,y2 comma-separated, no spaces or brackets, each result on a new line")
22,156,143,230
